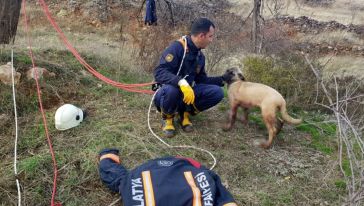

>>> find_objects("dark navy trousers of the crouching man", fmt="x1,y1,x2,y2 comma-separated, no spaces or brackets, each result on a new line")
154,84,224,114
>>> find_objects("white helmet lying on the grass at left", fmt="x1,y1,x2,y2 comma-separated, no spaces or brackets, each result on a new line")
55,104,86,130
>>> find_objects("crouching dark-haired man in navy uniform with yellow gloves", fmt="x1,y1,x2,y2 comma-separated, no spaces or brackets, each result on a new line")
154,18,228,137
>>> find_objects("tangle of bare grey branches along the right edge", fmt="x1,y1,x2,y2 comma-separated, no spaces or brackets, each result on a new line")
303,54,364,206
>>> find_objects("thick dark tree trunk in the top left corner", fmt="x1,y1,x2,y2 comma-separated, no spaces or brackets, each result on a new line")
0,0,21,44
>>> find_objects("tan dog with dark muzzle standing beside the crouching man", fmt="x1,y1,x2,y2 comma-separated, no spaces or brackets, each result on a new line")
223,68,302,149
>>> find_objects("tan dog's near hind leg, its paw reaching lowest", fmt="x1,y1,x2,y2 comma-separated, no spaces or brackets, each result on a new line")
261,108,277,149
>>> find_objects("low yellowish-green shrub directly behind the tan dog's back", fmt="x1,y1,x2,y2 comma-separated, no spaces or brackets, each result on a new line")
243,55,316,108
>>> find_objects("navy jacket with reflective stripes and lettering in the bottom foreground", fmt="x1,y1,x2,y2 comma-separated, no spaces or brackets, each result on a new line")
99,150,236,206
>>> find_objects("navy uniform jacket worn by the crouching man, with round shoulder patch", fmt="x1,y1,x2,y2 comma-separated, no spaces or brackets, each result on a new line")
154,36,224,87
